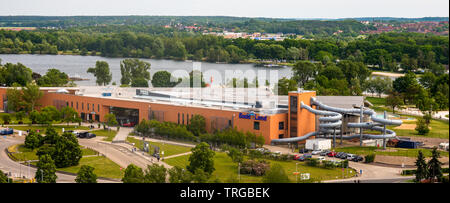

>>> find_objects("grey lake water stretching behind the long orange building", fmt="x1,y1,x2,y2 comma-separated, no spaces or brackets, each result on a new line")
0,54,292,85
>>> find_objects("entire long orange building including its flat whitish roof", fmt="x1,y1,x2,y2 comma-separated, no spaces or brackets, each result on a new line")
0,87,362,144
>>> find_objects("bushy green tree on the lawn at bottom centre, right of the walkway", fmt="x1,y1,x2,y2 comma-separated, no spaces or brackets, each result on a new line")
186,142,215,175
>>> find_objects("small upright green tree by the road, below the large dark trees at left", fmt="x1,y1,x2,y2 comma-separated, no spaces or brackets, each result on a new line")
35,154,58,183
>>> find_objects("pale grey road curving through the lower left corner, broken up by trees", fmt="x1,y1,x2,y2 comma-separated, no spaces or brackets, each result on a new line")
0,136,116,183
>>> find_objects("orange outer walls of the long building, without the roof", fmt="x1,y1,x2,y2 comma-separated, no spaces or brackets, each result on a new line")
0,88,316,144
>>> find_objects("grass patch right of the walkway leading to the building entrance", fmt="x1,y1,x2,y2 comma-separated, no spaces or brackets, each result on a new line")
127,137,191,157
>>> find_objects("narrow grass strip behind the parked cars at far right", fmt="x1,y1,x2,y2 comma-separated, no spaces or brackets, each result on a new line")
335,146,448,157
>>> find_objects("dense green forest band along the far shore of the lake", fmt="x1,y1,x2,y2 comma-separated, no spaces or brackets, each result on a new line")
0,26,449,71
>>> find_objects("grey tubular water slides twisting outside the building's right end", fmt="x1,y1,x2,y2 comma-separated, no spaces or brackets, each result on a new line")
272,97,402,145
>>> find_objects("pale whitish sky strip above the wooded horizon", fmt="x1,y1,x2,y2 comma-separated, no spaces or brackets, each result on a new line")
0,0,449,18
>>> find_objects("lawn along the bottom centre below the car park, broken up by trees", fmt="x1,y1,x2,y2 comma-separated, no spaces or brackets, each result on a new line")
164,152,355,183
